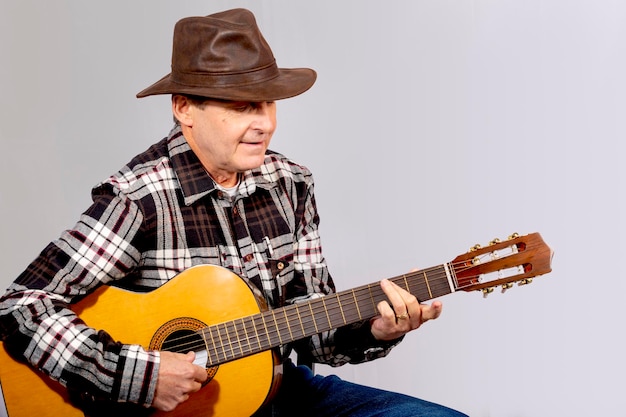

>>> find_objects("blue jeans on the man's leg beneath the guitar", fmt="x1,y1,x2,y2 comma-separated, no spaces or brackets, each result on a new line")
254,361,467,417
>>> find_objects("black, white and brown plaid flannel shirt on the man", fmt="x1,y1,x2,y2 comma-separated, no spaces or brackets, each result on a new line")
0,127,393,406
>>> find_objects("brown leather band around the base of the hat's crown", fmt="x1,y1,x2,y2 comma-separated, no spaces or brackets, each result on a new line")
171,62,280,87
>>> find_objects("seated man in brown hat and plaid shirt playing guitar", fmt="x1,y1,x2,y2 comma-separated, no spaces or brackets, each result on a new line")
0,9,460,416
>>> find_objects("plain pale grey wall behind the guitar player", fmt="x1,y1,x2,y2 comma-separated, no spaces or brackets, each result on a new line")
0,0,626,417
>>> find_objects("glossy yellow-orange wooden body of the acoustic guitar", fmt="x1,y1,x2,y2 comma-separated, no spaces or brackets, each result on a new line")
0,265,282,417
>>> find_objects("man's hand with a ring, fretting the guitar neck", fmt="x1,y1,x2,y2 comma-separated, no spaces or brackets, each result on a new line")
371,279,443,340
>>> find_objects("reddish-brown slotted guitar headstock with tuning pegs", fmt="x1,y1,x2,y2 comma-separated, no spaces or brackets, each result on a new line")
451,233,553,296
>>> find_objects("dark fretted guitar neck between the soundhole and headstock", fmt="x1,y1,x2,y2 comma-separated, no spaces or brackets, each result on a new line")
197,264,456,366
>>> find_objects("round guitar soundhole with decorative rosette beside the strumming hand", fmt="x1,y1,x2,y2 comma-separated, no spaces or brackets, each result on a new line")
150,317,219,385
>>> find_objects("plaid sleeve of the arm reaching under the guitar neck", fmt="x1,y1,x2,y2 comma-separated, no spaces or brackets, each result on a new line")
292,177,402,366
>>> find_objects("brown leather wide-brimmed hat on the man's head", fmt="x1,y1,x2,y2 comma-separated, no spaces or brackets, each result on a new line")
137,9,317,102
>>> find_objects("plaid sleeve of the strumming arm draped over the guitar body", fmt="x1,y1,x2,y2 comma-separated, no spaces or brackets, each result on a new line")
0,188,159,406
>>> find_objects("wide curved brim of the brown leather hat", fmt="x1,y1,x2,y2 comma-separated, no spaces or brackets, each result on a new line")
137,68,317,102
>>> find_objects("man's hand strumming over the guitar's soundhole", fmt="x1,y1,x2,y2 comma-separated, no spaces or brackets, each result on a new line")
152,351,207,411
